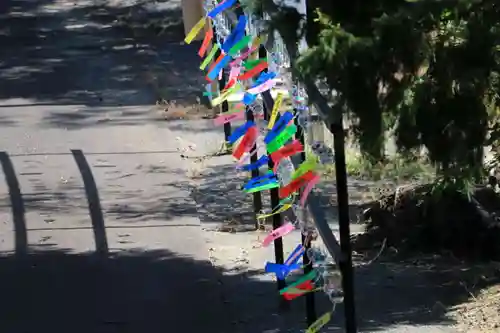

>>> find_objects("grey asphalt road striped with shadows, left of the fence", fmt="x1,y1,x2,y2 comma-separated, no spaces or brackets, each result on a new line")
0,1,232,333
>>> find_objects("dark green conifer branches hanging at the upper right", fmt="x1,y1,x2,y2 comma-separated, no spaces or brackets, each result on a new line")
243,0,500,191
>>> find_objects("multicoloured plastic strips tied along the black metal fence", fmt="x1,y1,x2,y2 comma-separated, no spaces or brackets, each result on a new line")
191,7,331,333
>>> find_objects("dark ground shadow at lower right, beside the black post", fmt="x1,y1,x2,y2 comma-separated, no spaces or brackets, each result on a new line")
355,256,500,330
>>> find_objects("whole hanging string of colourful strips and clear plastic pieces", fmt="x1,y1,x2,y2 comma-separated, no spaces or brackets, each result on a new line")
185,0,342,333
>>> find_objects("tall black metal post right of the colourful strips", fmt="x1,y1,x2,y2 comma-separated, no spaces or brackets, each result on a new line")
330,120,357,333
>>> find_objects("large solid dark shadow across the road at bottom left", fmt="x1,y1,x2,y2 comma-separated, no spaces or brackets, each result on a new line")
0,248,316,333
